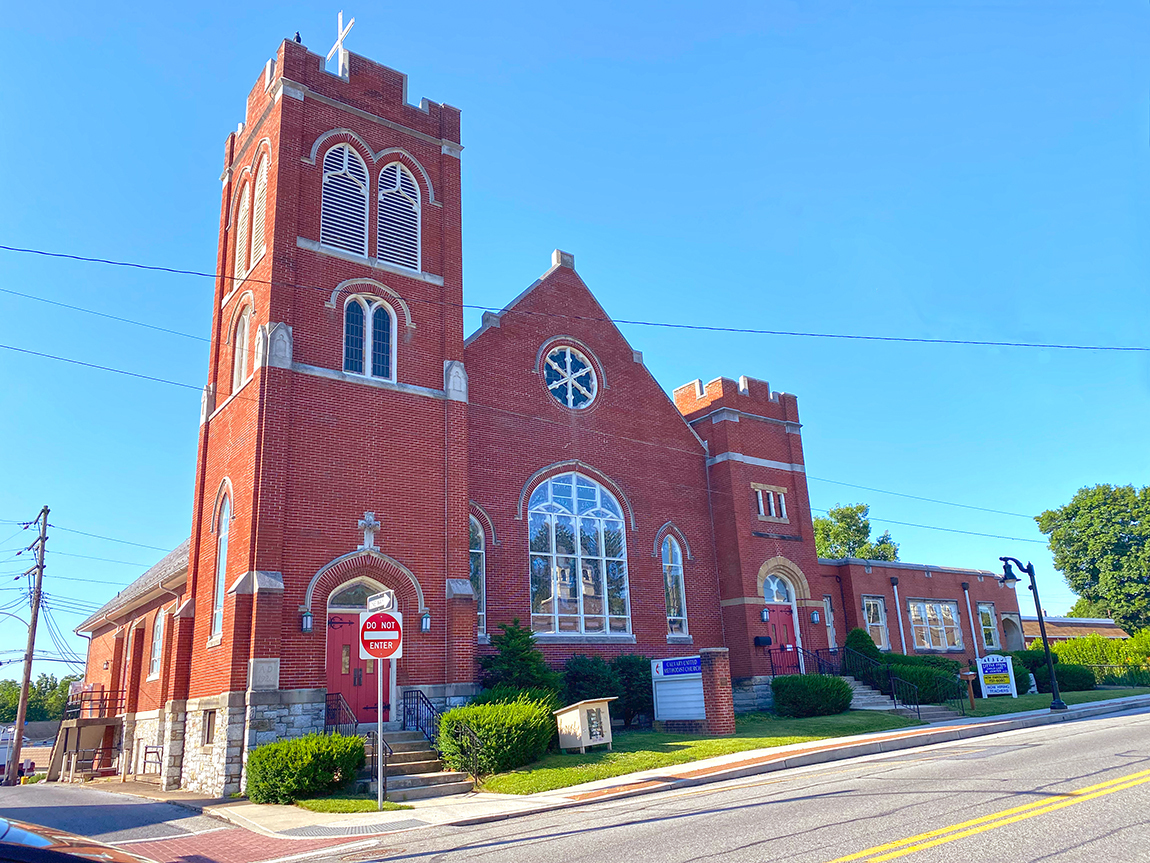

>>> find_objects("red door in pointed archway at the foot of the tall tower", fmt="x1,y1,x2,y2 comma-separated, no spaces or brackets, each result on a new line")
327,578,394,723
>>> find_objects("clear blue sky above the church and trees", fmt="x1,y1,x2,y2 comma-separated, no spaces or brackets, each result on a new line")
0,0,1150,677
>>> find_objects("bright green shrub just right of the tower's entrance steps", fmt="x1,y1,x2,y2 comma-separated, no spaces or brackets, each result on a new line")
439,701,555,774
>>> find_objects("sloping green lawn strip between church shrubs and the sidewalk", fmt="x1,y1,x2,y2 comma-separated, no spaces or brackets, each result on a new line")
482,710,919,794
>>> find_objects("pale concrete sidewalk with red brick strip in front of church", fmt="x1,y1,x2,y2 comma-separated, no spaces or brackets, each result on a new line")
100,695,1150,840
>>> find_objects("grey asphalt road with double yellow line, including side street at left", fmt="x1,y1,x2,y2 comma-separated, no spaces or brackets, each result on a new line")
0,710,1150,863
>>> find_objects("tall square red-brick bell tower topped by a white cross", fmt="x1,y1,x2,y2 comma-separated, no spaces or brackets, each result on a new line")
173,27,475,787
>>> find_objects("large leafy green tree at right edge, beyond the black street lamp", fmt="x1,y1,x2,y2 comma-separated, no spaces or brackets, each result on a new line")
1035,484,1150,633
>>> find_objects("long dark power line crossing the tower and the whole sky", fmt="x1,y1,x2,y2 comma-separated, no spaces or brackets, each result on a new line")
0,245,1150,353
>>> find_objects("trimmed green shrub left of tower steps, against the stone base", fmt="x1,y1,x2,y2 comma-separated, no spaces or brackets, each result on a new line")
247,734,363,803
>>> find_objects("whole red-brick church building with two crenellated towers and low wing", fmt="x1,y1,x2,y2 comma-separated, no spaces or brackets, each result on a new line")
78,35,1020,794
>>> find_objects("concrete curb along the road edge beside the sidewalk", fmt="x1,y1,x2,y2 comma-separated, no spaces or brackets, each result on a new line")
440,695,1150,827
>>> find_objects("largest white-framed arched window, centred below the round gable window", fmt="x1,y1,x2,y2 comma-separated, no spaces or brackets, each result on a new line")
527,473,631,635
